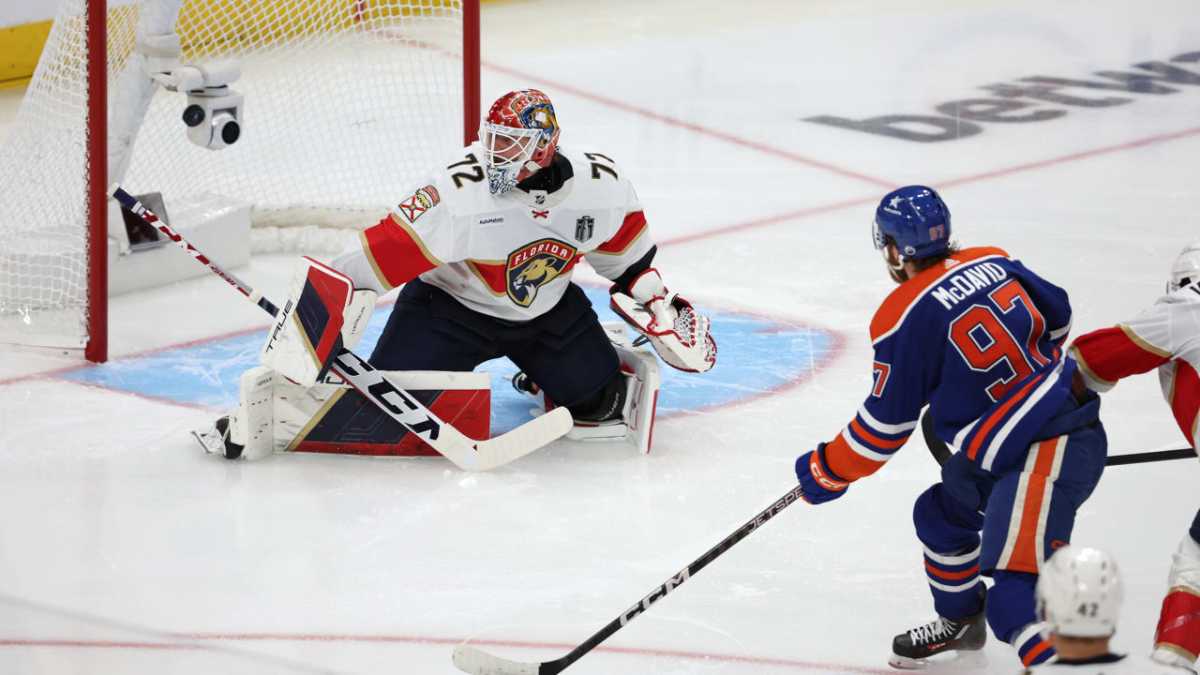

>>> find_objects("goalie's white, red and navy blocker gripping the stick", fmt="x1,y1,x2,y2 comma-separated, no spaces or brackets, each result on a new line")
260,258,377,387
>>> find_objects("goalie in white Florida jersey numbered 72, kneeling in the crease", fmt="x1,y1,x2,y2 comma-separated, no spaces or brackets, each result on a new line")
201,89,716,456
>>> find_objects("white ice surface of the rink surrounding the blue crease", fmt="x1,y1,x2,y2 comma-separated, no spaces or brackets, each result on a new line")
0,0,1200,675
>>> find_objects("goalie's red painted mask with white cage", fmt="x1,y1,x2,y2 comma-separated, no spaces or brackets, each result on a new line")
479,89,560,195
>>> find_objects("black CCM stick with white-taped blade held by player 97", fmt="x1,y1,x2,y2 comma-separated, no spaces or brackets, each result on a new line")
454,485,802,675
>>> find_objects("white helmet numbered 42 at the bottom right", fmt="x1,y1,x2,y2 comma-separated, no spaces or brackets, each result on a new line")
1037,546,1124,638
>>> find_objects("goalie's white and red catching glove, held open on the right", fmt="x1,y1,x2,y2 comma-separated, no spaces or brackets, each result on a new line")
610,268,716,372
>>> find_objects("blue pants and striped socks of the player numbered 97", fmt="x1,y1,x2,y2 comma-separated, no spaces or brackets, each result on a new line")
913,399,1108,665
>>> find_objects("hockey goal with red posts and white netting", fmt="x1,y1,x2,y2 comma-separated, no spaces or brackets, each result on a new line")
0,0,480,362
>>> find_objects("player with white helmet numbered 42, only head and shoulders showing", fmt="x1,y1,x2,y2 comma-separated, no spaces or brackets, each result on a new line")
1021,545,1188,675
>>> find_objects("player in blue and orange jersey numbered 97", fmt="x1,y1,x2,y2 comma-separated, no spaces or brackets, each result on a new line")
796,185,1106,668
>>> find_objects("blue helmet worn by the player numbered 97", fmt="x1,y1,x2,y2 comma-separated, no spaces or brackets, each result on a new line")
872,185,950,261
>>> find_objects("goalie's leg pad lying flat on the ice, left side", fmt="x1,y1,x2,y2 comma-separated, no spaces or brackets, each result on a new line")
192,366,492,460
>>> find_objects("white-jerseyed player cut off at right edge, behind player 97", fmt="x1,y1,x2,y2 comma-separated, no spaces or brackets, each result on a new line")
1072,241,1200,669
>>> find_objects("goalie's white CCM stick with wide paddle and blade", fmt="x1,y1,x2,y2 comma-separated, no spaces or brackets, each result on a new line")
109,185,574,471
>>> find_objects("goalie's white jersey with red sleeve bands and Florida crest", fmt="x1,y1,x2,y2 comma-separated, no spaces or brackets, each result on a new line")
331,143,653,321
